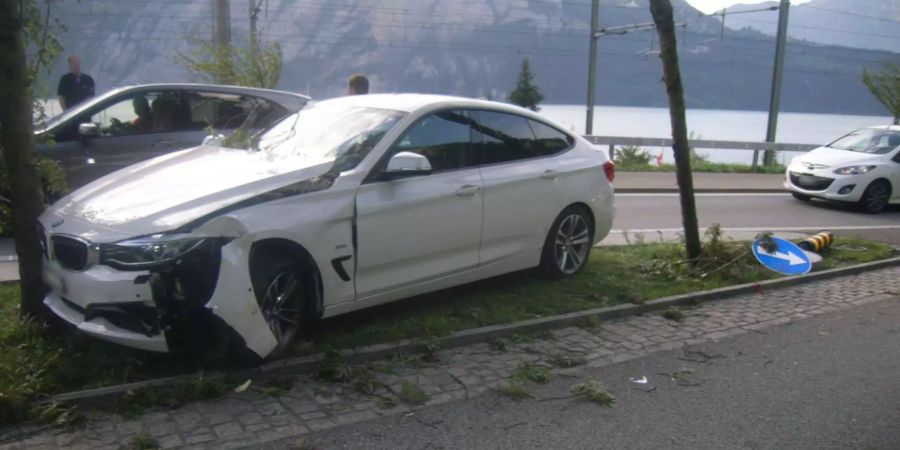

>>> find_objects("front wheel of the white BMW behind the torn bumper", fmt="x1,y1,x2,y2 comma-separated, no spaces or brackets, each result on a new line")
251,256,310,359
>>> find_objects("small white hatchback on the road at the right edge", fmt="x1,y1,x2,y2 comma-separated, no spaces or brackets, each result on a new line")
784,125,900,214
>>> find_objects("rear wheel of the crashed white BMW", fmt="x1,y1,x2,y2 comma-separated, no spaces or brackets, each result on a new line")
540,205,594,280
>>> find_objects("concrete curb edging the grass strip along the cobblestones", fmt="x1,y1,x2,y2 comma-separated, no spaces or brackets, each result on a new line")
44,257,900,405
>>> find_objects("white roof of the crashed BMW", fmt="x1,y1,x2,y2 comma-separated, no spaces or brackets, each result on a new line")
308,93,565,130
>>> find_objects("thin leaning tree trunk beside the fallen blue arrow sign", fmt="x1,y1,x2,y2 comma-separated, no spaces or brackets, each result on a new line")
650,0,701,262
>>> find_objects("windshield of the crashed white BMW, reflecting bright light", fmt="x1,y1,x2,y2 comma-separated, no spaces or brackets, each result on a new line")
222,103,404,171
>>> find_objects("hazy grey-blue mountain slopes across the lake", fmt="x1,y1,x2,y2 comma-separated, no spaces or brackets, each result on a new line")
40,0,897,114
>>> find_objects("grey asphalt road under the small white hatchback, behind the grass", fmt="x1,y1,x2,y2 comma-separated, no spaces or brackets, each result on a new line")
613,194,900,245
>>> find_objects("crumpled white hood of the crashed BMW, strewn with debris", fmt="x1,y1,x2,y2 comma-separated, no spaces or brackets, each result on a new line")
45,146,334,237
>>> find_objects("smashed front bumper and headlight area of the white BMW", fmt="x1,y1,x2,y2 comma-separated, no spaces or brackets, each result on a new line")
44,239,277,357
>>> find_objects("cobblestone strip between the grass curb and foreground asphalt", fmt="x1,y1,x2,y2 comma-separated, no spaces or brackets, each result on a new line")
0,267,900,450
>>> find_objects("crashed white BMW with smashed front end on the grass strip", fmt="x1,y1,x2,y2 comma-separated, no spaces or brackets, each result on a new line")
40,94,614,357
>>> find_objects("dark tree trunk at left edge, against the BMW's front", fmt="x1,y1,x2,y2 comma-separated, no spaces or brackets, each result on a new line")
0,0,44,317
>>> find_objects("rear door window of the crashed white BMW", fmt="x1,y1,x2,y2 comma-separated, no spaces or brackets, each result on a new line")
472,111,542,164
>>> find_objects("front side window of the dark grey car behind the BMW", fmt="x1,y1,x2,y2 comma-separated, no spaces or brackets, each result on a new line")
87,91,180,136
